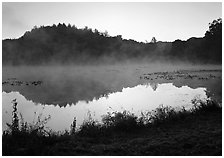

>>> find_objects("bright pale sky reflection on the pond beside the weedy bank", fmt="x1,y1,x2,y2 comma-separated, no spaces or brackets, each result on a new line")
2,83,207,131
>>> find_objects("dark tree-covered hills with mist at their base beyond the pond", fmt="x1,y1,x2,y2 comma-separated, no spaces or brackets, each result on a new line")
2,18,222,65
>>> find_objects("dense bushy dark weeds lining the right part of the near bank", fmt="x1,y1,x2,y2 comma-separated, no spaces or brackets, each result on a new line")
78,99,221,136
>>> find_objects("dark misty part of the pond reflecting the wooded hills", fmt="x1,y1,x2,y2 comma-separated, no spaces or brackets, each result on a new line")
2,66,222,106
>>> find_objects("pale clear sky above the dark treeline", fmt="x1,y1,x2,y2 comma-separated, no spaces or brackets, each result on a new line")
2,2,222,41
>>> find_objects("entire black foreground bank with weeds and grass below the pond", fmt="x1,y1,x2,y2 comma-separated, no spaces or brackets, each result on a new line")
2,100,222,155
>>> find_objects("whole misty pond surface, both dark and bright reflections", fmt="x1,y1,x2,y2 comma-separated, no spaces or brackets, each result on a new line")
2,65,222,131
